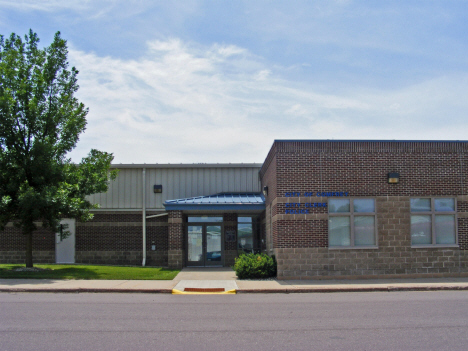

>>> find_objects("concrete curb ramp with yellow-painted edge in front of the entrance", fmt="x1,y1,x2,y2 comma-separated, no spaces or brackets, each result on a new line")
172,280,238,295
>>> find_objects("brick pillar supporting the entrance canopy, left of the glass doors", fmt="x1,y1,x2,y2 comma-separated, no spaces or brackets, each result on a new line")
168,211,185,269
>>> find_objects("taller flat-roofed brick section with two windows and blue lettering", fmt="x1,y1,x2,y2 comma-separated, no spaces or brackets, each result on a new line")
260,140,468,279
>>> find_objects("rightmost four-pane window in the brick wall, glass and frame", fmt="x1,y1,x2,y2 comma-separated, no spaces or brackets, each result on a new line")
410,198,457,246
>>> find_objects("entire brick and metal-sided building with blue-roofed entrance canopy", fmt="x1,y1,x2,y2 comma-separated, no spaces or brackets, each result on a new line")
0,140,468,279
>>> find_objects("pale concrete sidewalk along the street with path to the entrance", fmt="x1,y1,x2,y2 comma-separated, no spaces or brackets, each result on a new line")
0,268,468,294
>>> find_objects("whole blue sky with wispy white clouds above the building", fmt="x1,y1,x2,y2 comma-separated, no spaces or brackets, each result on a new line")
0,0,468,164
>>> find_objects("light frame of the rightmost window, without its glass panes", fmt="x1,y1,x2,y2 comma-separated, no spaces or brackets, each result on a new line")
410,196,459,249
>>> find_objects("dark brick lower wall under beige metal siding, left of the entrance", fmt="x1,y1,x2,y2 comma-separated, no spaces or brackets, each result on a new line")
0,211,169,266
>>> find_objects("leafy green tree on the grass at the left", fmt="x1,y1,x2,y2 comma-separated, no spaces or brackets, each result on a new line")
0,30,116,267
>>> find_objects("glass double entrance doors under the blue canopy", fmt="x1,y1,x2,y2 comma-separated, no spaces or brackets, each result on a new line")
187,224,223,267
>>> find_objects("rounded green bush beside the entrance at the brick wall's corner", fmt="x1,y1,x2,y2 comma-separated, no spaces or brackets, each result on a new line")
232,253,276,279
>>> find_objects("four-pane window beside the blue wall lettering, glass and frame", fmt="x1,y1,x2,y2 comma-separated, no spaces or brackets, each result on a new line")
328,199,377,247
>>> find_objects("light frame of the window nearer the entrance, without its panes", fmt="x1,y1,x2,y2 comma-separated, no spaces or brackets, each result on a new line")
327,197,379,250
